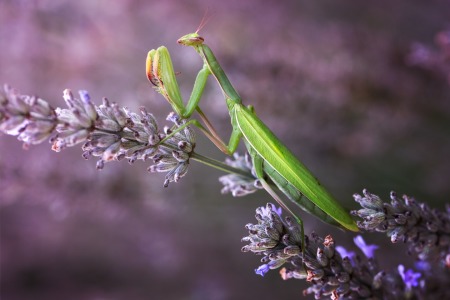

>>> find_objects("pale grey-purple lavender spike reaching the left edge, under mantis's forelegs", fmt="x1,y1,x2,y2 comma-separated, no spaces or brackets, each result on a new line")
0,86,195,186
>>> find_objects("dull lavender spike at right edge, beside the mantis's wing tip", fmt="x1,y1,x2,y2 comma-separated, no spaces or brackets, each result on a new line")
352,190,450,265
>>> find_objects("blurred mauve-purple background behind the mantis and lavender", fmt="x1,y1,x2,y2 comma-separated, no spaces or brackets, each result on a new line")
0,0,450,300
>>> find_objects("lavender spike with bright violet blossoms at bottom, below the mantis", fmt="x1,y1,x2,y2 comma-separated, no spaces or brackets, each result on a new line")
242,204,443,299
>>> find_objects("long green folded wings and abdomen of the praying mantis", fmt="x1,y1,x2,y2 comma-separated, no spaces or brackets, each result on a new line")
236,104,358,231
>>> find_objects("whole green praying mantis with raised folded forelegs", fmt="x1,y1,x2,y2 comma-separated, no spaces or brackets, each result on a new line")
146,30,358,241
